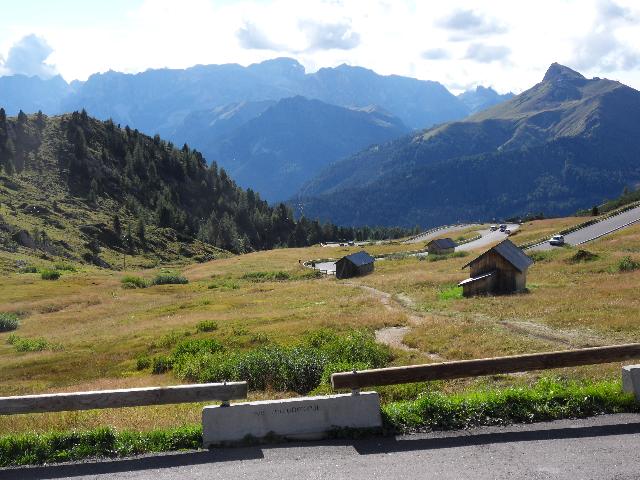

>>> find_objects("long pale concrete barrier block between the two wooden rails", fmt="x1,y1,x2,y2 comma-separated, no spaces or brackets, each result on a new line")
202,392,382,447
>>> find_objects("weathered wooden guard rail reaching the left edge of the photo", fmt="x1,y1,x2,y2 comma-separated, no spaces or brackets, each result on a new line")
0,382,247,415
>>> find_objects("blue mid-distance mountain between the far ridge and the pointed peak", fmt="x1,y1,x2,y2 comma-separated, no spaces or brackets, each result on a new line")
188,97,409,201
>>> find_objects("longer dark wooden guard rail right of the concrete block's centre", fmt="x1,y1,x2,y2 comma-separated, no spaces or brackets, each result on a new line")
331,343,640,389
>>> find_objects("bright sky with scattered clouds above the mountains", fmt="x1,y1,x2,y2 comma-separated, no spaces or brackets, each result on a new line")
0,0,640,93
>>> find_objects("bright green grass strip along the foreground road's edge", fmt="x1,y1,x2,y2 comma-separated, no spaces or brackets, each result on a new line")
0,378,640,467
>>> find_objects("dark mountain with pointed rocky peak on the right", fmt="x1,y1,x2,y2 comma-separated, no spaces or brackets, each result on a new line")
295,64,640,225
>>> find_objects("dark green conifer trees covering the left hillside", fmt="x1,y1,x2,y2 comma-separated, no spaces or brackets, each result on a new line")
0,109,416,253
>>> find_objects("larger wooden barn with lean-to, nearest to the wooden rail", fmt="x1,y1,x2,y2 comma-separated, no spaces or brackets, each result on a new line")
458,240,533,297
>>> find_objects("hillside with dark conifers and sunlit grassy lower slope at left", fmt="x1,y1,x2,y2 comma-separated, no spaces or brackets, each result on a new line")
0,109,412,266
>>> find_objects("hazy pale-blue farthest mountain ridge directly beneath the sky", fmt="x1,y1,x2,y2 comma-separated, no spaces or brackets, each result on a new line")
0,58,508,136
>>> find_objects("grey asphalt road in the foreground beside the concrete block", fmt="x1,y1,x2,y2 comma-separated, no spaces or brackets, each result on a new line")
8,414,640,480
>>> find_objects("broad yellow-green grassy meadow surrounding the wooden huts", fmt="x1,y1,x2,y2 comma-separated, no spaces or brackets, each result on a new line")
0,218,640,434
